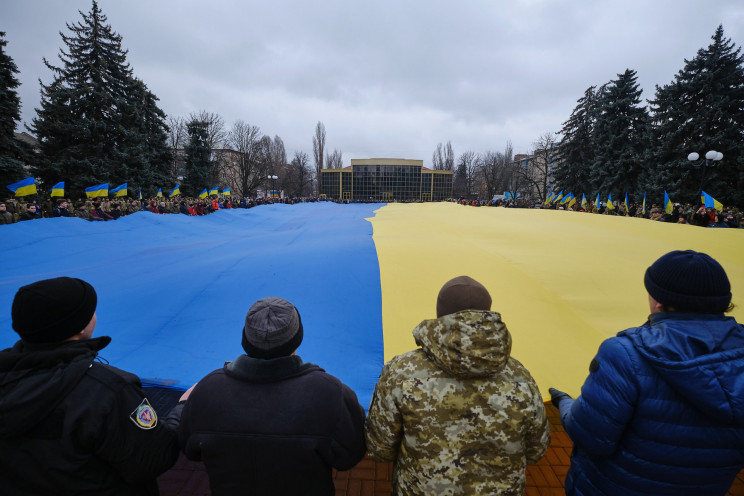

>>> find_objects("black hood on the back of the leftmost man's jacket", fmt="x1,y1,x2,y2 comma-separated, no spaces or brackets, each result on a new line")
0,336,111,438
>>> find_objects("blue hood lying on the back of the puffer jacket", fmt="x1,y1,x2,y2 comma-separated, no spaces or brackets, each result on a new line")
620,313,744,425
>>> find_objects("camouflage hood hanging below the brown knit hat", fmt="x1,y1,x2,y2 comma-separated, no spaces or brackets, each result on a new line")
413,310,511,377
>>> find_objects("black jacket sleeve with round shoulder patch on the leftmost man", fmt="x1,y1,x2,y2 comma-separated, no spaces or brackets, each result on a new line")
89,368,183,483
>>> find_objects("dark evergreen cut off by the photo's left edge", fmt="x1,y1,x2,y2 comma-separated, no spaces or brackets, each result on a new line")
0,31,29,184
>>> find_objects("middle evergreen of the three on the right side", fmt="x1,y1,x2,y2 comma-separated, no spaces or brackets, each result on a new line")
591,69,649,198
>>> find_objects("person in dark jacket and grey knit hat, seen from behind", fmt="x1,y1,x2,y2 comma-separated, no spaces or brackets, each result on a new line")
179,297,365,496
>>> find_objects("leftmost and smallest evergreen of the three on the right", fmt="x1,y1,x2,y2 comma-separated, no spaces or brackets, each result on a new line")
553,86,602,196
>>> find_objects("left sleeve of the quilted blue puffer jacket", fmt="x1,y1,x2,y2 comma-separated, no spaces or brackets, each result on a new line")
561,337,639,456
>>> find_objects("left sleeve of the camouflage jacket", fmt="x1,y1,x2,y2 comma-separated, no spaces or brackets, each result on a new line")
365,362,403,462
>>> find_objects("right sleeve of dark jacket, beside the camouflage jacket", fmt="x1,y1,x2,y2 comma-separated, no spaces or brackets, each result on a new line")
331,384,367,470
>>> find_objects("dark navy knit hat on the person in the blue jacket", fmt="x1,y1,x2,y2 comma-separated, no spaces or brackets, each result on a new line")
643,250,731,313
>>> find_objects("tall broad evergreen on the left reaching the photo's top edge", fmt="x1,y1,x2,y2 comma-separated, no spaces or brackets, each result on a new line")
29,1,170,195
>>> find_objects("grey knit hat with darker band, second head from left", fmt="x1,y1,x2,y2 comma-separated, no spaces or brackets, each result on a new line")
242,296,302,359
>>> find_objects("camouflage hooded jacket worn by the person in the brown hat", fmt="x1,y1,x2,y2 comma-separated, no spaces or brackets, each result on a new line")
365,310,550,495
